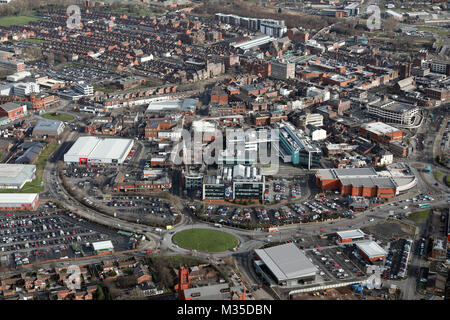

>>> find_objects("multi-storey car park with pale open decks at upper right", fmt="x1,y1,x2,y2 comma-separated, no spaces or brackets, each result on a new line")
367,99,420,126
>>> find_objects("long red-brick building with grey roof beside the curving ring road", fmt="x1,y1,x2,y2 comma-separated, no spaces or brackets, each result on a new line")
316,168,397,198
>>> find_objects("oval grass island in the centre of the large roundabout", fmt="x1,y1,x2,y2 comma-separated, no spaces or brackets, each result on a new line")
173,229,238,252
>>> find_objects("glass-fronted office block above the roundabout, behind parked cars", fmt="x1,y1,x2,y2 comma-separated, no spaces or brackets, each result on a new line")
203,164,265,201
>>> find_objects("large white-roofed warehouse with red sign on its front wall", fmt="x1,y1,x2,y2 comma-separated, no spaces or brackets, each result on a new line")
64,136,134,166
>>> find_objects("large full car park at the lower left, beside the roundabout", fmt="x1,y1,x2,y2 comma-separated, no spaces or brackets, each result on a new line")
0,203,131,268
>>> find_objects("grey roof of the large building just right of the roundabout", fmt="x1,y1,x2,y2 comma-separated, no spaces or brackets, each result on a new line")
255,243,318,281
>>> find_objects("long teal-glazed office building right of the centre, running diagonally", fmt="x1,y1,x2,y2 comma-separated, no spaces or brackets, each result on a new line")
276,122,322,169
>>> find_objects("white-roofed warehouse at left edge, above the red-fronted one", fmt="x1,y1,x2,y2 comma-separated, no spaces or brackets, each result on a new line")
0,163,36,190
